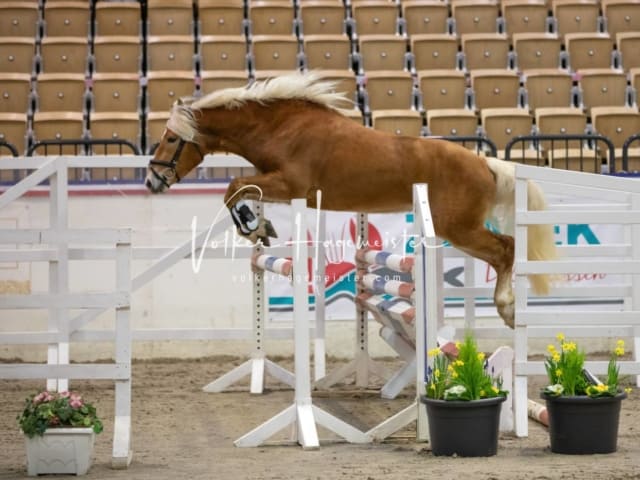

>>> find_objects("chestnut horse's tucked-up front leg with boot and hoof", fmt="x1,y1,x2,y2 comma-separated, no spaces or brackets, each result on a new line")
224,173,291,246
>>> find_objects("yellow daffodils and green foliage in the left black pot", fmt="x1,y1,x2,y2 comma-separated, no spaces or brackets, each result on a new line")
426,334,507,401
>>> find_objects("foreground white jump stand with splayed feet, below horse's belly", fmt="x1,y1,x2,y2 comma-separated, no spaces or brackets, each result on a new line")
234,199,369,449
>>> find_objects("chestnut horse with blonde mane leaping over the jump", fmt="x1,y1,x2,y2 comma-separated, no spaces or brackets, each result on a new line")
145,73,555,327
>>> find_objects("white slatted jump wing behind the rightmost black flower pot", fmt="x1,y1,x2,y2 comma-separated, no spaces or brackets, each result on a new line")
514,165,640,436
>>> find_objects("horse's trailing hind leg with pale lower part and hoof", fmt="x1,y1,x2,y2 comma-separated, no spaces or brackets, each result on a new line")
449,227,515,328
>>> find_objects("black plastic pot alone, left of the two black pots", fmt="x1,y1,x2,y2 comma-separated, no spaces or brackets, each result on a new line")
420,395,506,457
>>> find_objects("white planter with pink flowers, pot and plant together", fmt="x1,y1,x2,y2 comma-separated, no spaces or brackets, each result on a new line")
18,391,102,476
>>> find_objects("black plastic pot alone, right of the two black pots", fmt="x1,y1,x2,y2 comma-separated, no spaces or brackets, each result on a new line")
540,393,627,455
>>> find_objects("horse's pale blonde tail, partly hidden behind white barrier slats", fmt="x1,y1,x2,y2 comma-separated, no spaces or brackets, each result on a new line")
486,157,556,295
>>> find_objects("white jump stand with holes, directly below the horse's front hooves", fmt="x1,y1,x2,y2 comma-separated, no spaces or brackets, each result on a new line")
202,202,295,395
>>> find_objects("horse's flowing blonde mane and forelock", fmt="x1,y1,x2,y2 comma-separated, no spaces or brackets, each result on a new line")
167,72,349,141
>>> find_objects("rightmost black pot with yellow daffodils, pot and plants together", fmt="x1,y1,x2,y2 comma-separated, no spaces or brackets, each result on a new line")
541,333,630,454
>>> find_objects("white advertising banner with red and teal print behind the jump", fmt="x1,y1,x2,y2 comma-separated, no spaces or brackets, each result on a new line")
265,201,623,320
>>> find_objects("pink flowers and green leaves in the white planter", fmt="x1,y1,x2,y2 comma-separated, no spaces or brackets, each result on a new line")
18,391,103,438
